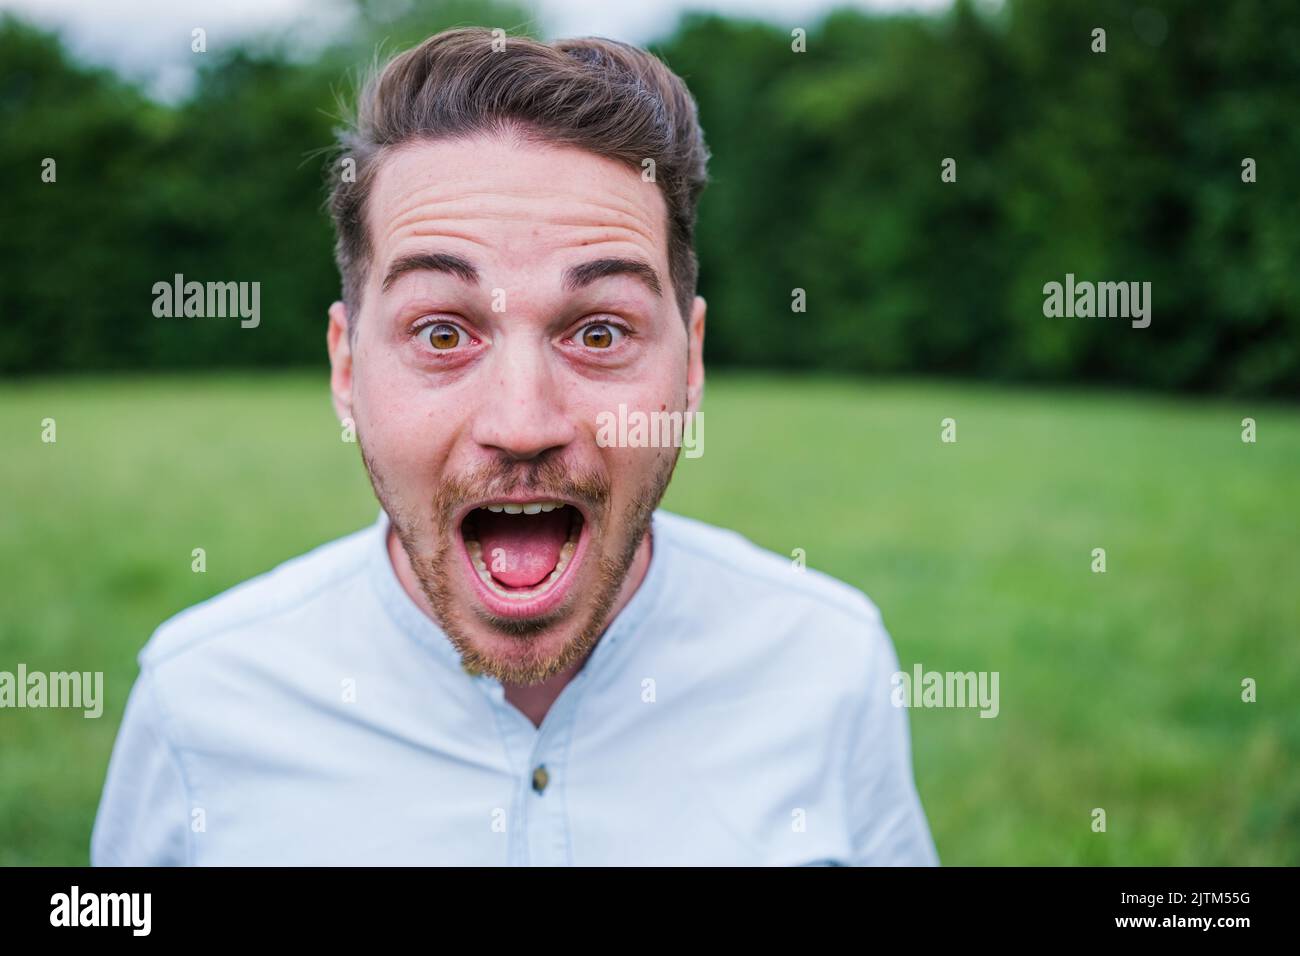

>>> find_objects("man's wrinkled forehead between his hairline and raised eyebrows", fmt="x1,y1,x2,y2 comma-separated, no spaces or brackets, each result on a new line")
367,134,667,283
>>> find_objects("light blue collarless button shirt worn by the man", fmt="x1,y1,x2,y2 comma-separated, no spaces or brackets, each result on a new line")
91,511,939,866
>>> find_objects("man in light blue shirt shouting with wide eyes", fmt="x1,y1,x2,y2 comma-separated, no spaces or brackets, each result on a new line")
92,30,937,865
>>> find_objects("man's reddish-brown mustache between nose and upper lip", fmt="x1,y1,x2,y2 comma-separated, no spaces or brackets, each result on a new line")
433,457,611,533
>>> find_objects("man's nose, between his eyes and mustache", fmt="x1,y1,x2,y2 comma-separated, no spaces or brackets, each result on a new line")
472,337,577,462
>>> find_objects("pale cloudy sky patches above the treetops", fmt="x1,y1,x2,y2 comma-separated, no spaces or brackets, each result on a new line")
0,0,949,99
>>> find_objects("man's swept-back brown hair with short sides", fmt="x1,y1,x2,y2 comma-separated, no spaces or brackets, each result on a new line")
329,27,709,329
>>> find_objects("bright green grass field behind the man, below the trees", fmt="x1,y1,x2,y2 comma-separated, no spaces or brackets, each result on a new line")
0,375,1300,865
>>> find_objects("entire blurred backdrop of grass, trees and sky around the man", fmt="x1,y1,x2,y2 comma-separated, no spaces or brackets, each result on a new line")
0,0,1300,865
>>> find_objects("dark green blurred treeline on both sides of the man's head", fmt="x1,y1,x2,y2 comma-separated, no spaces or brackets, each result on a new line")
0,0,1300,397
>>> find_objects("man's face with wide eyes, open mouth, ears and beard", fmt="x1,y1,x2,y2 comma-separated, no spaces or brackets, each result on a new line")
329,137,703,684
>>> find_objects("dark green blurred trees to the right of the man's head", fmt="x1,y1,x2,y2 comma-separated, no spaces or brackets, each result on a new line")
658,0,1300,395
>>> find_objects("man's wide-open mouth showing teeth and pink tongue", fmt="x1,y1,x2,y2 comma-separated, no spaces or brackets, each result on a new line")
460,499,586,617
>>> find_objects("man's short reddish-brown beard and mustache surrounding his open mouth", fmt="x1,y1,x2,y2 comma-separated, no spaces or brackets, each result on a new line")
356,431,680,684
